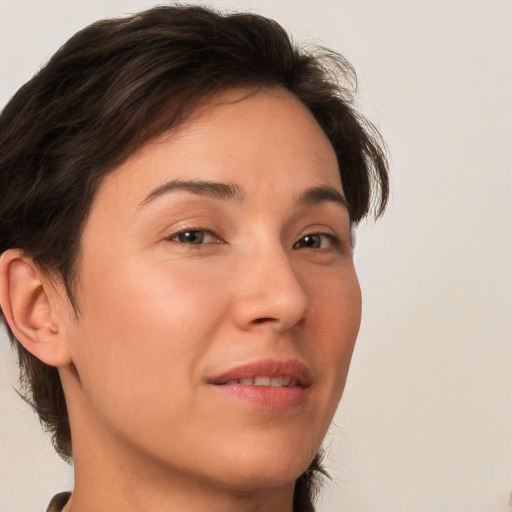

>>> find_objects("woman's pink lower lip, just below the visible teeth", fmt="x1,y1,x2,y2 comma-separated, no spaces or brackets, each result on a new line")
209,384,308,411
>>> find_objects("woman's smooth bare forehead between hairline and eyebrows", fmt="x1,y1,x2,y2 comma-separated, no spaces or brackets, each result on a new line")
93,88,342,214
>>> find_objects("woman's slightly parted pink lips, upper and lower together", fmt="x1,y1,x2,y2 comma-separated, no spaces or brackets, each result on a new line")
207,359,311,411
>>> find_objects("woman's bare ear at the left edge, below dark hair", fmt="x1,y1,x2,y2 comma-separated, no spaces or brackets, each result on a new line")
0,249,71,367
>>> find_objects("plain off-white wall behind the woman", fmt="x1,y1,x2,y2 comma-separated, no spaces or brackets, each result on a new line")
0,0,512,512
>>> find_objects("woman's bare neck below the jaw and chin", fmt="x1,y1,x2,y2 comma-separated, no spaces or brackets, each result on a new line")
64,372,295,512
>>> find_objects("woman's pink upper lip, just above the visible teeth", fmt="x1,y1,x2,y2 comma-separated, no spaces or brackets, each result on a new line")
208,359,311,388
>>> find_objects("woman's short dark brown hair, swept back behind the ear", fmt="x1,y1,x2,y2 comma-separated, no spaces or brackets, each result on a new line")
0,6,388,510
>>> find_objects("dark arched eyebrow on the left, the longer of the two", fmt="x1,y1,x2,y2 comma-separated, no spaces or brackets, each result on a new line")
139,179,245,207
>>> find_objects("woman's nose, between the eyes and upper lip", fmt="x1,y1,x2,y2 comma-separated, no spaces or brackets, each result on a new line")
232,244,309,332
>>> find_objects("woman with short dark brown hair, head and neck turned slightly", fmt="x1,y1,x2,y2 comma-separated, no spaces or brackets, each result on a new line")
0,7,388,512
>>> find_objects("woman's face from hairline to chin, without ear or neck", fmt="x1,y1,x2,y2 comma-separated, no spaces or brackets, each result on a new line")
58,89,361,490
